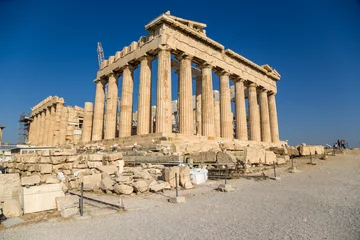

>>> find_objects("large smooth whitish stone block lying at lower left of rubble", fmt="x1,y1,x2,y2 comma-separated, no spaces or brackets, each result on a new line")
22,183,64,213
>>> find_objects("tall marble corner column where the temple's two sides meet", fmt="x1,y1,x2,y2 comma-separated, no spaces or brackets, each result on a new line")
156,48,172,133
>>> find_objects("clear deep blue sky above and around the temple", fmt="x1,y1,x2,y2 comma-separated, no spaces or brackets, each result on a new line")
0,0,360,147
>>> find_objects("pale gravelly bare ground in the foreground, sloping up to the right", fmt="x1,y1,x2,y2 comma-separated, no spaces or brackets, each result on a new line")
0,154,360,240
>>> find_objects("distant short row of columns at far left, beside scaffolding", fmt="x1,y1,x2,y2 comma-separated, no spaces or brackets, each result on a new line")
28,102,67,146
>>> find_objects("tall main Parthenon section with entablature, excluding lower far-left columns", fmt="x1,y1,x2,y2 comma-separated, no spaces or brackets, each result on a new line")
86,12,280,143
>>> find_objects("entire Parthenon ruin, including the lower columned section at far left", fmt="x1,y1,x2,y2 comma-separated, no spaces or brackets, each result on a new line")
28,12,280,146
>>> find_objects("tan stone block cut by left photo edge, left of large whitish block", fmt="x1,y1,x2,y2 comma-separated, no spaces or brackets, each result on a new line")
0,173,21,202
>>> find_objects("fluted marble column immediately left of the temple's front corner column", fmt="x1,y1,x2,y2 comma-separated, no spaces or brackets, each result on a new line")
137,56,153,135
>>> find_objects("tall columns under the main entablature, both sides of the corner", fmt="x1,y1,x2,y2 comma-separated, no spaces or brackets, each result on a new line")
91,47,279,142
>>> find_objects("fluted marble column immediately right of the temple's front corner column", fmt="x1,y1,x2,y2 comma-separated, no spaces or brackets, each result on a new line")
179,55,194,135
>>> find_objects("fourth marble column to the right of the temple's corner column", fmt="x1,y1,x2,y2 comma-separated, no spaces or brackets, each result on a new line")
235,79,248,141
